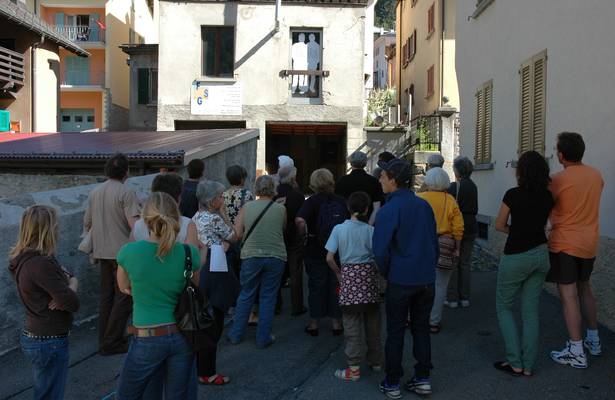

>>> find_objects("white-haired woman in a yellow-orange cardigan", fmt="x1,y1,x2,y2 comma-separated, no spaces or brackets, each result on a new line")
417,167,463,333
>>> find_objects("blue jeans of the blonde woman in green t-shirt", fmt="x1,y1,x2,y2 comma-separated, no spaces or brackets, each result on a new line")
117,333,197,400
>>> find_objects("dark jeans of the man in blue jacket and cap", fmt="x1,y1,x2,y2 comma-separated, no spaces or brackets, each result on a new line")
384,282,435,385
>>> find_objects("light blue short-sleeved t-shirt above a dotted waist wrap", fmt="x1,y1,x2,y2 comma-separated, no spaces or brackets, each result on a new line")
325,219,374,264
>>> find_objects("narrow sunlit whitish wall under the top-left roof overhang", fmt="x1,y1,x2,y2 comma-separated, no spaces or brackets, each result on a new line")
34,46,60,132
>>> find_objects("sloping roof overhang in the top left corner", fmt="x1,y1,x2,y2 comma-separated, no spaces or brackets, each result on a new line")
0,0,90,57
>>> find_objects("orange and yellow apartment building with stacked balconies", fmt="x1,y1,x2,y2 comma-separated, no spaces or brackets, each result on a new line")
28,0,157,132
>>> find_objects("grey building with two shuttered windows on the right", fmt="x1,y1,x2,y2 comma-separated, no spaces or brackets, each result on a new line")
458,0,615,284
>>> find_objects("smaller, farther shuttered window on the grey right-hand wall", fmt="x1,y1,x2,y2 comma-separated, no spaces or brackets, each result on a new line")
474,81,493,164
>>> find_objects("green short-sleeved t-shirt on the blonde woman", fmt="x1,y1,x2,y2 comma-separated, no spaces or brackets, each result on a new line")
117,240,201,327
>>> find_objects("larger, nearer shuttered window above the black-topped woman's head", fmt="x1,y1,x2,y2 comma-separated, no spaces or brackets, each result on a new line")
518,50,547,156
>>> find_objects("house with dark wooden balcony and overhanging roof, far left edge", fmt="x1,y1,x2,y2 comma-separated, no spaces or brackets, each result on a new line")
0,0,89,132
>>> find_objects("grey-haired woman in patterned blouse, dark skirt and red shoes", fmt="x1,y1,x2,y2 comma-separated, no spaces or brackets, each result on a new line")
192,180,239,385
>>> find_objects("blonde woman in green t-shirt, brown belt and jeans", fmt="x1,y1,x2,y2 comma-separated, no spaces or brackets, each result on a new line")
117,192,201,400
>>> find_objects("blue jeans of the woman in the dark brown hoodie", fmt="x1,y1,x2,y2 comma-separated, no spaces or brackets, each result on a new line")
19,334,68,400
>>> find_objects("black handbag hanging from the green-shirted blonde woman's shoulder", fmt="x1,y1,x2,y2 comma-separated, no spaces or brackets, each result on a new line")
174,244,217,351
